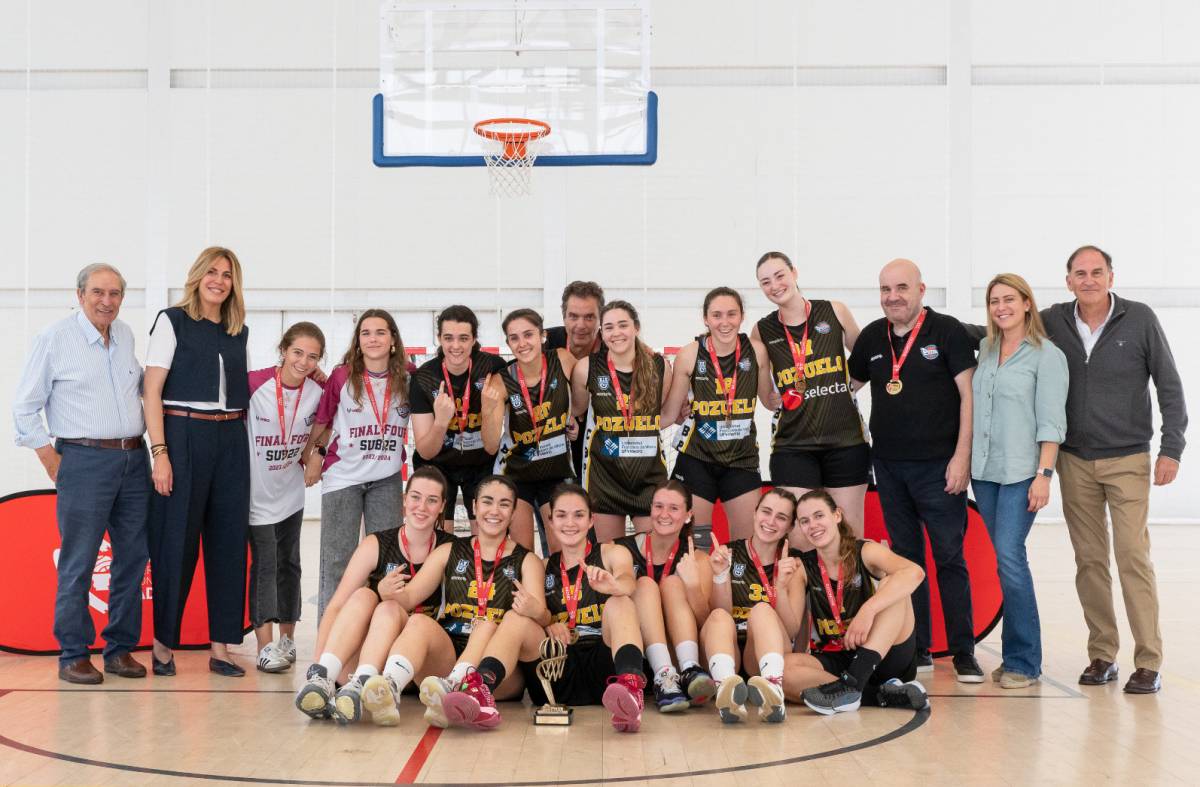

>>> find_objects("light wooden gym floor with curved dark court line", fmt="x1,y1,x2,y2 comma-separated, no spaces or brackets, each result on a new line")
0,522,1200,787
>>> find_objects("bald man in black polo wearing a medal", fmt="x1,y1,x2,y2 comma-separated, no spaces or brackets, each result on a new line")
848,259,983,683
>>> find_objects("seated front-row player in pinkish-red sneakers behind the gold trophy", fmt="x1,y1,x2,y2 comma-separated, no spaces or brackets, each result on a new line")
444,483,646,732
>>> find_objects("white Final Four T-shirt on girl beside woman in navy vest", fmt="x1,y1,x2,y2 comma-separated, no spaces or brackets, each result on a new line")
246,366,322,524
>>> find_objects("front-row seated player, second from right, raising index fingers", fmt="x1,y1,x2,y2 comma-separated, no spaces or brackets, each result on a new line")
701,489,804,723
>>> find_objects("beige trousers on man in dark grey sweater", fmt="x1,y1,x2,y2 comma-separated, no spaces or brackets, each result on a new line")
1058,451,1163,672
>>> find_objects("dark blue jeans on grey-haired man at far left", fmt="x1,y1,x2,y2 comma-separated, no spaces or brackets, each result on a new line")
54,443,150,665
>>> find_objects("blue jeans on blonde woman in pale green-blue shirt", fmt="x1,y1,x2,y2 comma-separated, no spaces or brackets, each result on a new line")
971,477,1042,678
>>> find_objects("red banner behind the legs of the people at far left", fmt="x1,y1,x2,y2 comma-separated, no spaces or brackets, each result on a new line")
0,489,250,654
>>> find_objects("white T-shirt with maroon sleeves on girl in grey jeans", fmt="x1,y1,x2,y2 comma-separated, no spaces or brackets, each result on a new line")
317,366,409,494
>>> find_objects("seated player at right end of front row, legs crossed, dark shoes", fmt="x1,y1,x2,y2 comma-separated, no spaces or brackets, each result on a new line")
785,489,929,715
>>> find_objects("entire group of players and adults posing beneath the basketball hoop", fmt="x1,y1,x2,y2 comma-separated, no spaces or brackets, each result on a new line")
13,246,1187,732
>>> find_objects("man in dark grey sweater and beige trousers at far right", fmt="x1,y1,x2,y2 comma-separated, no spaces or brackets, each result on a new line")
1042,246,1188,693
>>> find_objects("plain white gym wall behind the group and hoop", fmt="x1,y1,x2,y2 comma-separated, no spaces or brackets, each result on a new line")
0,0,1200,522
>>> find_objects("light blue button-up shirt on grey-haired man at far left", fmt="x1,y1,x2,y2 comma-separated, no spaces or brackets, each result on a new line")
12,312,145,449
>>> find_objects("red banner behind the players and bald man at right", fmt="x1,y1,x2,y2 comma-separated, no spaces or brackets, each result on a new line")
713,486,1003,655
